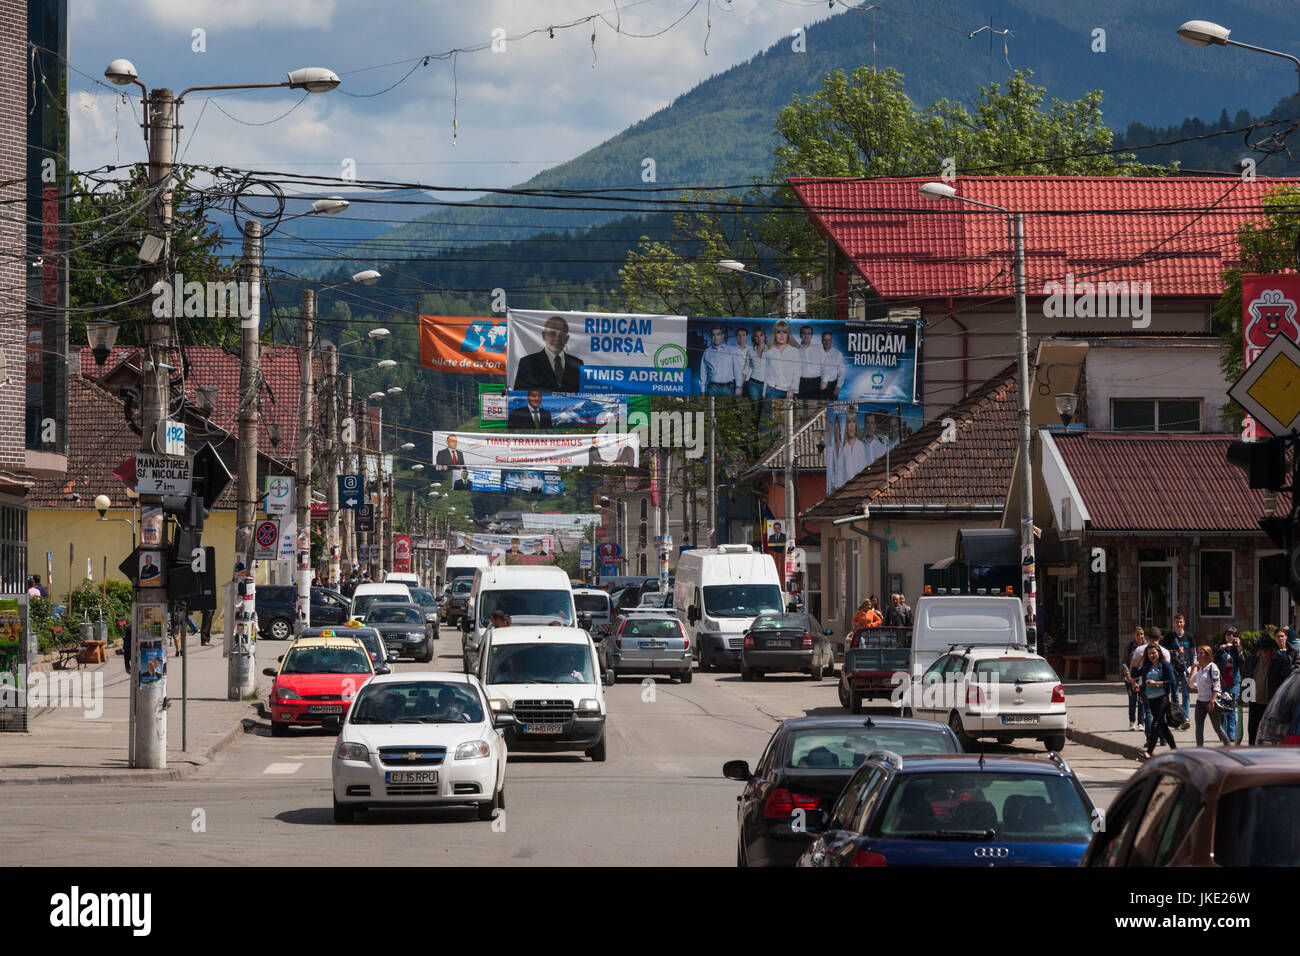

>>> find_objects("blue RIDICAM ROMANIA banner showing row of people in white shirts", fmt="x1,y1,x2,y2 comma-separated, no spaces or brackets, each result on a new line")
686,316,920,406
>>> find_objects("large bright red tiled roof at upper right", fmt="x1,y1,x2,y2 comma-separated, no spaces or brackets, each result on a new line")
789,176,1300,299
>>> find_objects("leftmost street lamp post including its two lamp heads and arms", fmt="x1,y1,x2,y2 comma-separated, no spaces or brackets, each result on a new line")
102,60,339,770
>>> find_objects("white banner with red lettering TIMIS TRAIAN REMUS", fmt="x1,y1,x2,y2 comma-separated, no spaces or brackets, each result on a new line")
433,432,641,470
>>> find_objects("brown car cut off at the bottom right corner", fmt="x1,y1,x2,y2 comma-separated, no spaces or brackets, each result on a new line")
1082,747,1300,866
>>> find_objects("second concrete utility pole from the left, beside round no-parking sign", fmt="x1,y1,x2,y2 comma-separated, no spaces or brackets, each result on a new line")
226,220,261,700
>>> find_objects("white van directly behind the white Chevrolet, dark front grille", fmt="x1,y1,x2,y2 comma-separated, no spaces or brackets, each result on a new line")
477,629,606,761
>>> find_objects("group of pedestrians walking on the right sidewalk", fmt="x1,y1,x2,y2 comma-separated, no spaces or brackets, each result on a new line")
1125,614,1300,757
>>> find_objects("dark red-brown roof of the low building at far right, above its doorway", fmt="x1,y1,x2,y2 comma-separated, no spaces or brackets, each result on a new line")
1052,433,1290,532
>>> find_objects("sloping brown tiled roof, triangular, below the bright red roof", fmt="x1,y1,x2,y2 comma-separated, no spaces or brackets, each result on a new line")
803,364,1019,519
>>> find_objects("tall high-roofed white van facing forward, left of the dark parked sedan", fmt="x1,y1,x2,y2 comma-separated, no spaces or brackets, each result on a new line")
672,545,785,671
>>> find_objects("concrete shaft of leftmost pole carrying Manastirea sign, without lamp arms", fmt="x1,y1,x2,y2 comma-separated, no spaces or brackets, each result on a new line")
131,90,176,770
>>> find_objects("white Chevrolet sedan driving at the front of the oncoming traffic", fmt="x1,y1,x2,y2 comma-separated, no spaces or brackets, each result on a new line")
330,671,506,823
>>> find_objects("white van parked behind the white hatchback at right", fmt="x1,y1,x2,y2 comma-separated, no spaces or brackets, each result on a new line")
911,594,1030,680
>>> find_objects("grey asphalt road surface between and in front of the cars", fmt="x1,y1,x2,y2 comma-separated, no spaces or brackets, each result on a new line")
0,632,1136,866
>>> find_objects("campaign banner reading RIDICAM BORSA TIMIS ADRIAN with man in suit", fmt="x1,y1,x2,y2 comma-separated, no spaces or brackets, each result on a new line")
506,310,688,395
